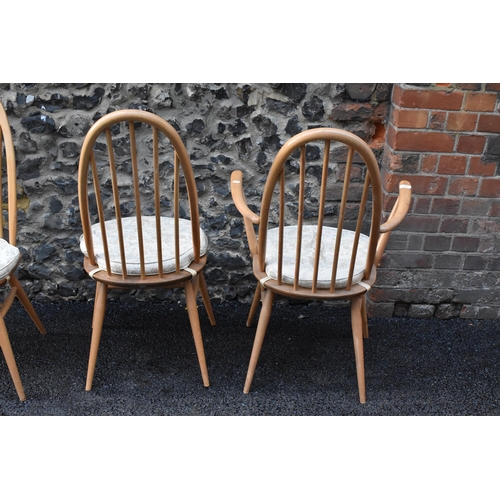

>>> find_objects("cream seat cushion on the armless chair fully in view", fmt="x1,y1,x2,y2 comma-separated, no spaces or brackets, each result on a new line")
80,216,208,276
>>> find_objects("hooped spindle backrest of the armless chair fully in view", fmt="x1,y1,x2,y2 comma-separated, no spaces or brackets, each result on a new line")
78,109,200,278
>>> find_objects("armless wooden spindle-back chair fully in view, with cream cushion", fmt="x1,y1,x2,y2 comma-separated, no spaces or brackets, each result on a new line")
78,109,215,391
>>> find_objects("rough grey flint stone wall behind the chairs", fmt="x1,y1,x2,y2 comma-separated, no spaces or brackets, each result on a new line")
0,83,392,302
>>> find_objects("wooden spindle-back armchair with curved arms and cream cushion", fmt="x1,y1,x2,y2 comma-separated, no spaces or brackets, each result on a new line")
231,128,411,403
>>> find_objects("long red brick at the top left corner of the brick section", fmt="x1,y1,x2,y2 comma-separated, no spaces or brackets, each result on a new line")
392,85,464,111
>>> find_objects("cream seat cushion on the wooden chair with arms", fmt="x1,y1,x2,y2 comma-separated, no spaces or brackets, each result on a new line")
266,226,370,288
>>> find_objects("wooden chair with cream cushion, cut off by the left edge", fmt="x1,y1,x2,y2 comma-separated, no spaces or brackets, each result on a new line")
0,103,45,401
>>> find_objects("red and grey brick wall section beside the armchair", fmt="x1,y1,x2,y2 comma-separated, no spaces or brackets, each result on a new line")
370,83,500,318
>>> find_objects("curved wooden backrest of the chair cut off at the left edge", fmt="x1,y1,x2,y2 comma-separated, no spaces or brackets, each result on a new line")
0,103,17,246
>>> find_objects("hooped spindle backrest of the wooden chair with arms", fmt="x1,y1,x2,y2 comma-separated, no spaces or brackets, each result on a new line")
258,128,382,291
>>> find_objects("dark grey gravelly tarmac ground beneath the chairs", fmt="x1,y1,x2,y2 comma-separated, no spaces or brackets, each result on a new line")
0,301,500,416
